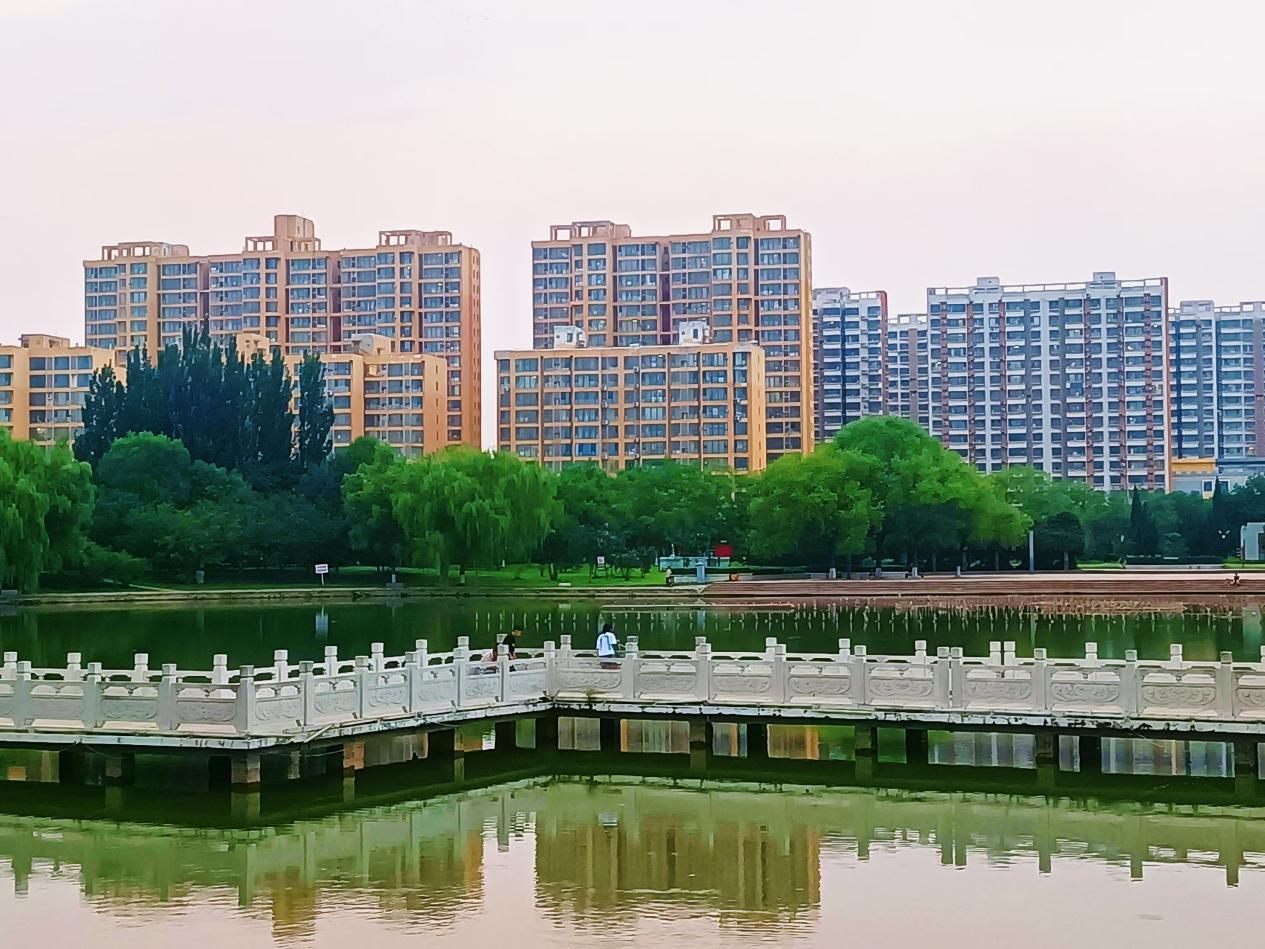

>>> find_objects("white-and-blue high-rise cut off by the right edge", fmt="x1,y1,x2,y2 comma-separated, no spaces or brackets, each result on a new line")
1169,300,1265,462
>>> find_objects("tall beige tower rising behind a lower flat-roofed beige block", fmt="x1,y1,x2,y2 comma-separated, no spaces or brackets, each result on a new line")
531,214,815,461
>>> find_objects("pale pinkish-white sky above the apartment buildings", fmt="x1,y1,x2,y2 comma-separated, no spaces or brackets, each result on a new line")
0,0,1265,445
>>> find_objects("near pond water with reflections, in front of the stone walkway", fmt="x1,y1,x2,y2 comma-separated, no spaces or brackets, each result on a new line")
0,778,1265,949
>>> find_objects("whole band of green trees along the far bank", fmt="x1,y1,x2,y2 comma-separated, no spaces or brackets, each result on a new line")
0,409,1265,590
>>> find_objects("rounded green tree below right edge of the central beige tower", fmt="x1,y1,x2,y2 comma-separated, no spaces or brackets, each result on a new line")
749,444,880,567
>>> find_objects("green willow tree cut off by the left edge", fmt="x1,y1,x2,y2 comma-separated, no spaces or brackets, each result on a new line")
0,430,94,590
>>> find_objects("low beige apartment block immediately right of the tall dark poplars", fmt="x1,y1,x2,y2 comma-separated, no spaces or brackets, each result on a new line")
237,333,448,457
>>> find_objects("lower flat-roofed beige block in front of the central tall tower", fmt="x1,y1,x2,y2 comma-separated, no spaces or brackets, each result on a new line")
496,325,768,472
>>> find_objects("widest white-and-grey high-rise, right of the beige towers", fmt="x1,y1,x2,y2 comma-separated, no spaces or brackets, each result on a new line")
927,272,1169,491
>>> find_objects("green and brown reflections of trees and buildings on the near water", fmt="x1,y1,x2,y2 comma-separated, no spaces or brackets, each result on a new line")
0,778,1265,935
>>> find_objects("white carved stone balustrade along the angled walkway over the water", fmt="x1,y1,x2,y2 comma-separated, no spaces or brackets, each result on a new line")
0,635,1265,738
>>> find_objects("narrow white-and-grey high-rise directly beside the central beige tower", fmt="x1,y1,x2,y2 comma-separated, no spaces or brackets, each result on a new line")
812,287,898,443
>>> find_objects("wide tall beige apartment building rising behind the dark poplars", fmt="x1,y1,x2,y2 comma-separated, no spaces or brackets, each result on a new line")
83,214,482,445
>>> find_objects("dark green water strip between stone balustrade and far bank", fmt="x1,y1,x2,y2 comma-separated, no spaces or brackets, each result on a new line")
0,593,1265,668
